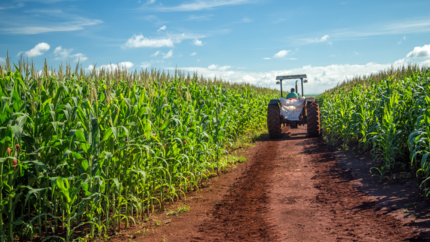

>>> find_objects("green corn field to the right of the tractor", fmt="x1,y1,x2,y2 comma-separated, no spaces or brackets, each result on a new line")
319,65,430,191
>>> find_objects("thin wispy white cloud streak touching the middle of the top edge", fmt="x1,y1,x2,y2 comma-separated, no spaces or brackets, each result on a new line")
151,0,252,12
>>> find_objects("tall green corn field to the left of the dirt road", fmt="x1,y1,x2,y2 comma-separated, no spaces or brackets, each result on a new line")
0,55,278,241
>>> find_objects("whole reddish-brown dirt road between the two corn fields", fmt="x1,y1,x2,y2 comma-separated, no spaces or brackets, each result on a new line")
113,126,429,241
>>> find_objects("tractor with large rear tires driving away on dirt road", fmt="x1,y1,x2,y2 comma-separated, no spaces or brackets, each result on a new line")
267,74,321,138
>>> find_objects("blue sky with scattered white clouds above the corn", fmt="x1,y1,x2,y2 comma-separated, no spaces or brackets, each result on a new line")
0,0,430,94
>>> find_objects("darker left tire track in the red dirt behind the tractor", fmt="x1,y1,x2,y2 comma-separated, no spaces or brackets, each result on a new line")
194,133,280,241
